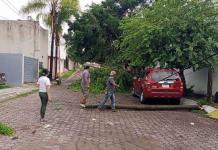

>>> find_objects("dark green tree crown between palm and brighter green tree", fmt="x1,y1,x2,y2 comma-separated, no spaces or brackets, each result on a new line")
65,0,151,63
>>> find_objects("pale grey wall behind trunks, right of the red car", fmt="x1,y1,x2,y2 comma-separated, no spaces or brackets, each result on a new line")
185,65,218,95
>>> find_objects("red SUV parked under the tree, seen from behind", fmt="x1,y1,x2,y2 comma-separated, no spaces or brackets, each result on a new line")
133,68,183,104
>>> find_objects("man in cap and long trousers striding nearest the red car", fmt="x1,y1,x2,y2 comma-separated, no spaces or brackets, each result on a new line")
98,71,119,111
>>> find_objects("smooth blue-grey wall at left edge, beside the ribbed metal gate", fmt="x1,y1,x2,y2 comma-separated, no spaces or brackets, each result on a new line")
0,53,24,86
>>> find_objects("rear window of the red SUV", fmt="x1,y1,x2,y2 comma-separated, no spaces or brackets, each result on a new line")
151,71,179,81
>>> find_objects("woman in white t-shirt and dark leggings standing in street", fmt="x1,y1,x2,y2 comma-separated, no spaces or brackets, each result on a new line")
37,69,51,122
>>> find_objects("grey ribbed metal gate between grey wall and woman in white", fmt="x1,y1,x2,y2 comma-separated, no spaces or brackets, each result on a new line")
24,57,38,83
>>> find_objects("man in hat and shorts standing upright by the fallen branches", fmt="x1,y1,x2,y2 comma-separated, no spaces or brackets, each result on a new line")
80,65,90,108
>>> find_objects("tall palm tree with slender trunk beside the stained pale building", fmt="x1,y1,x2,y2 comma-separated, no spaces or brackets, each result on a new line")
21,0,78,79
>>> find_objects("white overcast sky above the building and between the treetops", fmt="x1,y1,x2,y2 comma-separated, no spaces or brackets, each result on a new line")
0,0,102,20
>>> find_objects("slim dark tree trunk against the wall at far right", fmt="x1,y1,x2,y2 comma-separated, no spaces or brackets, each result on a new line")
207,66,213,101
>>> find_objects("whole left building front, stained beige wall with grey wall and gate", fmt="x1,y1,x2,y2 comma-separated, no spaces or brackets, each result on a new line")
0,20,48,85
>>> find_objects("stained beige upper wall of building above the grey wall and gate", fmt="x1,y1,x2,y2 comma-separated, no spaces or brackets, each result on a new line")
0,20,48,68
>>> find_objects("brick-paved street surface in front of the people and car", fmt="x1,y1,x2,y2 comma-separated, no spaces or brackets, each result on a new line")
0,74,218,150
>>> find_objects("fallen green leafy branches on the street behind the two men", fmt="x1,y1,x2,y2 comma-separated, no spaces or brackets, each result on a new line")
69,66,132,94
